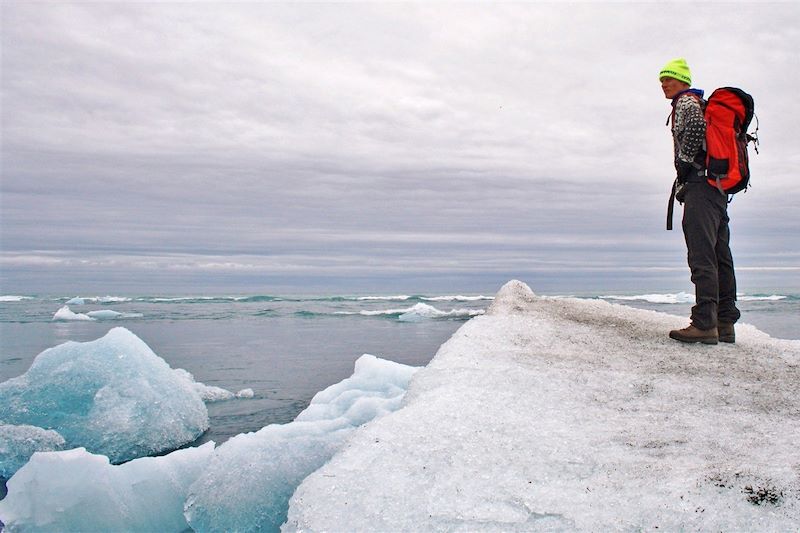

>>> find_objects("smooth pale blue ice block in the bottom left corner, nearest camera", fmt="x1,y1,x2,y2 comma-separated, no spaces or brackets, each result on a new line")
0,442,214,533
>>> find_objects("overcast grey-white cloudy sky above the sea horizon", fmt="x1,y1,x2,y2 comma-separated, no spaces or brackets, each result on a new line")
0,1,800,294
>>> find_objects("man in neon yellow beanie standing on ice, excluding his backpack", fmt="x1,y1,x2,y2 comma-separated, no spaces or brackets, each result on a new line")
659,59,740,344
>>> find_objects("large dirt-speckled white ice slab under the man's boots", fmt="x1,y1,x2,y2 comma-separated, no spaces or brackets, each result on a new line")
284,282,800,531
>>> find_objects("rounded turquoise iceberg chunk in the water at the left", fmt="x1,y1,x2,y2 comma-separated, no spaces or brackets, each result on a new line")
0,328,208,470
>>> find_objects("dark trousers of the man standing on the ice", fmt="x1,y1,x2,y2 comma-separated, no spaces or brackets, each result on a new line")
683,182,741,329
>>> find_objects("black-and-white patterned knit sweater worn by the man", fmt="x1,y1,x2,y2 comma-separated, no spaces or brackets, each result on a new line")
672,89,706,168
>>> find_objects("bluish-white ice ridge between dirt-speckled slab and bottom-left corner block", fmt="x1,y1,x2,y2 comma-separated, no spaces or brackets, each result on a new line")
186,354,417,531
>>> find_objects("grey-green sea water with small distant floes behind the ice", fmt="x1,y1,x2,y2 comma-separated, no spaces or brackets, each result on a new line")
0,291,800,497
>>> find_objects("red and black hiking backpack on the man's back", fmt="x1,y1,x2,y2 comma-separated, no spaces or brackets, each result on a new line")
705,87,758,194
